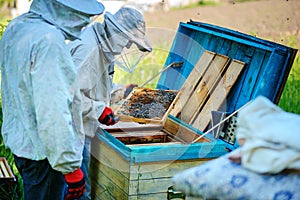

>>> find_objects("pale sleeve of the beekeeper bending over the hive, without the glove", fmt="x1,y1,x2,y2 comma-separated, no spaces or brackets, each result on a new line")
69,37,106,121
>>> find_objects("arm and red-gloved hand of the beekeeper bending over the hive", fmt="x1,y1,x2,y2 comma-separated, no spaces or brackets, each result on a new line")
71,41,115,125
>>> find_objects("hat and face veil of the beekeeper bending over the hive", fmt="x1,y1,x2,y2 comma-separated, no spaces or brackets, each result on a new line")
104,7,152,72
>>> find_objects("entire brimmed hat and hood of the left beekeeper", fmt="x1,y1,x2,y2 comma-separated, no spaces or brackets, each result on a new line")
29,0,104,40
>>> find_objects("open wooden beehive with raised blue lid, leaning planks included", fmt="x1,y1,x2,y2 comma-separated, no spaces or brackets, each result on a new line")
91,19,296,200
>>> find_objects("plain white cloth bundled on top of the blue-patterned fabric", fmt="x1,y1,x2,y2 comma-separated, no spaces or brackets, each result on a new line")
237,96,300,173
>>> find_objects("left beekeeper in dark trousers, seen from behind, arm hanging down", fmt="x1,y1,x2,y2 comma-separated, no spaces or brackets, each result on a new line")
0,0,104,200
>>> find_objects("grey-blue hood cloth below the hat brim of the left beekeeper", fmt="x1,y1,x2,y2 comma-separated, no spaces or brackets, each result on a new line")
29,0,102,40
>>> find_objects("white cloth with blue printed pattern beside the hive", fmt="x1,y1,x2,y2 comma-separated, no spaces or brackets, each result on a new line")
172,150,300,200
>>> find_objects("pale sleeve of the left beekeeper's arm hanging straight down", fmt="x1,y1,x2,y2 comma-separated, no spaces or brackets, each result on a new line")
31,34,84,174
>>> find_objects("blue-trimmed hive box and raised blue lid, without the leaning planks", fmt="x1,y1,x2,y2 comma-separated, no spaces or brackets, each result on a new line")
91,22,296,200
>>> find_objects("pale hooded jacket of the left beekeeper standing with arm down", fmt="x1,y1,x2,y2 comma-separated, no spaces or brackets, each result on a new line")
0,0,89,174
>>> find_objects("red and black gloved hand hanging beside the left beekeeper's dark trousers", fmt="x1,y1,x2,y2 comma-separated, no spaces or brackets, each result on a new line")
65,168,86,200
